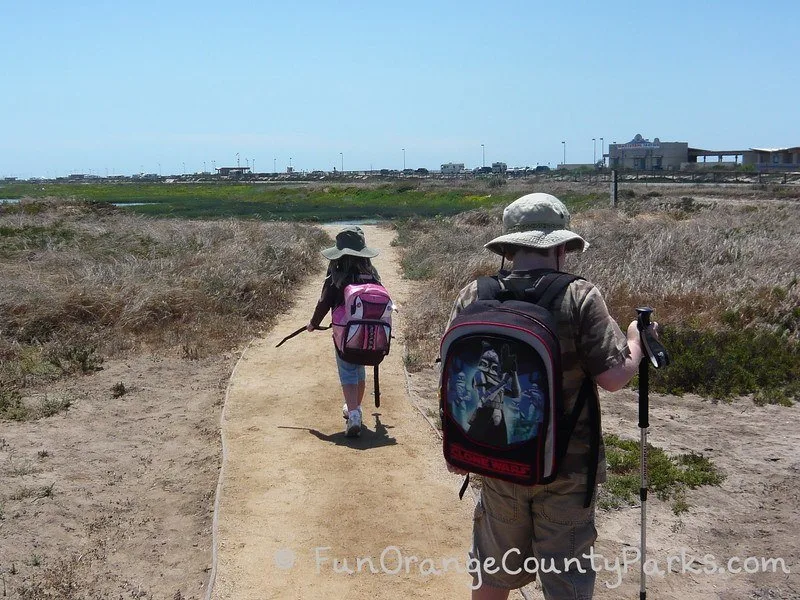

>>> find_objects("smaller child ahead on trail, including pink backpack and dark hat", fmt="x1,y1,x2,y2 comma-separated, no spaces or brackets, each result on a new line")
306,226,393,437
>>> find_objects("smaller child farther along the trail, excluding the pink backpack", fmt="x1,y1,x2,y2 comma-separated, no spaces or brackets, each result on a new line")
306,226,391,437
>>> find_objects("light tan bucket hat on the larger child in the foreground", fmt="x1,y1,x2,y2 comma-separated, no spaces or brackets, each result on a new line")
484,192,589,255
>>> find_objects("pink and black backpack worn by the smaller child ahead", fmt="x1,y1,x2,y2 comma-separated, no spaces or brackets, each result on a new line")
331,283,394,365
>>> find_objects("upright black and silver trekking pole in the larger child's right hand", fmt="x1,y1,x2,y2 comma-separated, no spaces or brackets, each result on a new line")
636,307,669,600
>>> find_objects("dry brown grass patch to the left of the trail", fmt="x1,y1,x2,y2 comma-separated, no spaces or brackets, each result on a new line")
0,203,328,396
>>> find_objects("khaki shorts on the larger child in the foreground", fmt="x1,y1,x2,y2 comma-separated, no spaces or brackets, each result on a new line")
470,477,597,599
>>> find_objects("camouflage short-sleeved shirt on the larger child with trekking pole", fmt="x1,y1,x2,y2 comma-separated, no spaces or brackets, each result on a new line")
448,272,630,485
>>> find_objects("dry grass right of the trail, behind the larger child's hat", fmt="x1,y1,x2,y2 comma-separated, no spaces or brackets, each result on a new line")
399,188,800,400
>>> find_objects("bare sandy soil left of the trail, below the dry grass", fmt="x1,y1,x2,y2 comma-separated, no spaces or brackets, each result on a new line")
0,356,234,599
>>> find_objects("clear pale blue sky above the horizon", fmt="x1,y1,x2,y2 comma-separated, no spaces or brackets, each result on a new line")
0,0,800,177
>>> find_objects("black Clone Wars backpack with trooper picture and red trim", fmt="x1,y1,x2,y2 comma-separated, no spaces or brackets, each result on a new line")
439,271,599,495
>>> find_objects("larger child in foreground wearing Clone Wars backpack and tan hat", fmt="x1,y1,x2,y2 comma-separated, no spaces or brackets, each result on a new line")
441,193,655,600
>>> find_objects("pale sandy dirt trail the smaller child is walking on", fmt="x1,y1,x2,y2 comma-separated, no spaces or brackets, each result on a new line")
212,226,473,600
